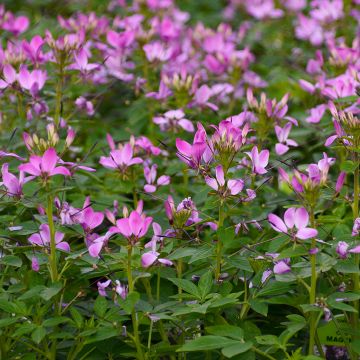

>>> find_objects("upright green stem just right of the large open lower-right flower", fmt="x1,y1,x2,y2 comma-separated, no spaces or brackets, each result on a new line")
309,207,317,355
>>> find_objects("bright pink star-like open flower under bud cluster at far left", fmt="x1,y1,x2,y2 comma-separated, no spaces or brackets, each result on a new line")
19,148,71,180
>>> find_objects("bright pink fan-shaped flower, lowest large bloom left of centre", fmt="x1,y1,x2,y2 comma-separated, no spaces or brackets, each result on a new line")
110,210,152,244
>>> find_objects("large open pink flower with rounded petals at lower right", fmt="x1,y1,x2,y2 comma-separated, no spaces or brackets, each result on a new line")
268,208,318,240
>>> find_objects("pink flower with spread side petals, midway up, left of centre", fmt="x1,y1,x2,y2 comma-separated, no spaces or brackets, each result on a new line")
99,143,143,173
